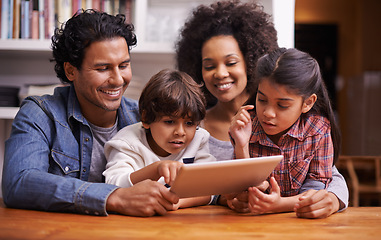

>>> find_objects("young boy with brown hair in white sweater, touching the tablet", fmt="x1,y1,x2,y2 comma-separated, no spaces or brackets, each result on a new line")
103,70,215,208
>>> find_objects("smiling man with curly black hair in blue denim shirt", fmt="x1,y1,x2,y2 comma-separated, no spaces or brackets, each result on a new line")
2,10,178,216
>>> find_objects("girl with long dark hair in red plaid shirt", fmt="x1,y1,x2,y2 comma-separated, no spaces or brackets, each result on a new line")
229,48,341,214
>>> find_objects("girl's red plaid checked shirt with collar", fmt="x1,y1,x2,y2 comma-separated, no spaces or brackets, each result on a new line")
245,112,334,197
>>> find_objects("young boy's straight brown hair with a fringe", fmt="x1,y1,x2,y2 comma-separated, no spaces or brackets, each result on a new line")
139,69,206,124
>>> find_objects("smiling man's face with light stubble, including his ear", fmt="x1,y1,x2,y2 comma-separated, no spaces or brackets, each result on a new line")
68,37,132,125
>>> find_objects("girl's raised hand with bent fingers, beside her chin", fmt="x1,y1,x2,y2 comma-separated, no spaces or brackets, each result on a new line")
229,105,254,148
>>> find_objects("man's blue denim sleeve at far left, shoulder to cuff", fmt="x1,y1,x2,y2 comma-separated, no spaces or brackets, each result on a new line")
2,103,117,215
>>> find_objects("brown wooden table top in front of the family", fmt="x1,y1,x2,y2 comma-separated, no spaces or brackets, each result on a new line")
0,202,381,240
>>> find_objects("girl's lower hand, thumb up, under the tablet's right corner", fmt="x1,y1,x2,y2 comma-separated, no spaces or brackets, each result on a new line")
249,177,282,214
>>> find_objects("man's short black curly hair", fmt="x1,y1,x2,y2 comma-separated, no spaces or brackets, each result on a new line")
51,9,136,83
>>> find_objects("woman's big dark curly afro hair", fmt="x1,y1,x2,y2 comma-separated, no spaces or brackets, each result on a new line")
176,0,278,106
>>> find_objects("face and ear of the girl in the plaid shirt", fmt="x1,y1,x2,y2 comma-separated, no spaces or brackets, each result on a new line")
256,78,316,144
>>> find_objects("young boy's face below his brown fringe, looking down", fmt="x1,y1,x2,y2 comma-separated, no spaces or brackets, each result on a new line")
143,116,197,157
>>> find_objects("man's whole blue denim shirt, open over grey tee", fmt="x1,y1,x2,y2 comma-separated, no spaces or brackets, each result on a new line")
2,85,140,215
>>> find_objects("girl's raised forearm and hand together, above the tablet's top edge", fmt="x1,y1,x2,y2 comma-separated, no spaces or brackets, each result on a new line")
229,105,254,159
